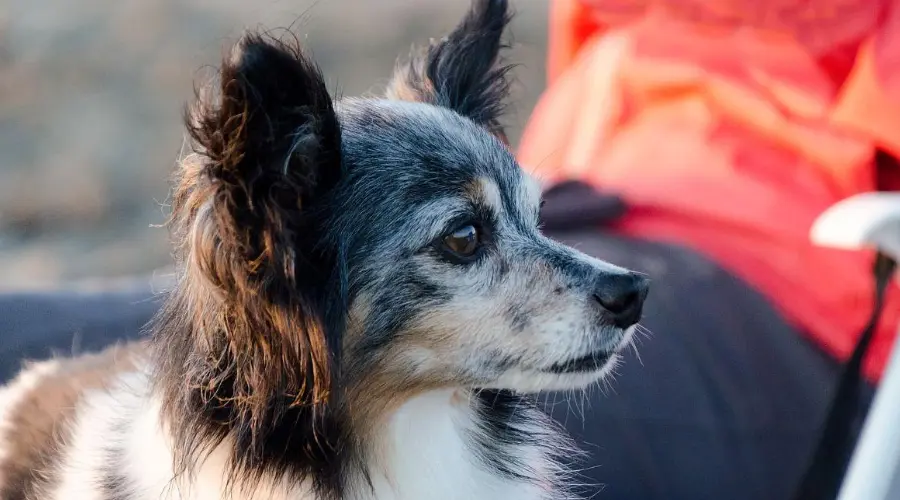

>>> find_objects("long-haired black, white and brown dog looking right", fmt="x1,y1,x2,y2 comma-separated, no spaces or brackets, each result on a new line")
0,0,648,500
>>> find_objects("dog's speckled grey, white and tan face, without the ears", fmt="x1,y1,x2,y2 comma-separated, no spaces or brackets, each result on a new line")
329,100,647,391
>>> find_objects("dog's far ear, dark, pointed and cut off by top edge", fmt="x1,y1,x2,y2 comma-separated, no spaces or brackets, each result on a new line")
387,0,511,142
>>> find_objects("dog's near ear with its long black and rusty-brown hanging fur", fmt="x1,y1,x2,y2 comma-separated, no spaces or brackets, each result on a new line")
155,30,341,488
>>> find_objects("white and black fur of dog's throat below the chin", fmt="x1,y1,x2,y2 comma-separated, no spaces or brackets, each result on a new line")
347,389,555,500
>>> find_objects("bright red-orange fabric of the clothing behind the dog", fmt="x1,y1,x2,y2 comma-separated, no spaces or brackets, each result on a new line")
519,0,900,380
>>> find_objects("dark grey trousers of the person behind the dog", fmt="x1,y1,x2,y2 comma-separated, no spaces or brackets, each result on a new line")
0,230,871,500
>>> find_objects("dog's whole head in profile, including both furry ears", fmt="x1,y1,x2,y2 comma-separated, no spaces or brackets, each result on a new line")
156,0,647,478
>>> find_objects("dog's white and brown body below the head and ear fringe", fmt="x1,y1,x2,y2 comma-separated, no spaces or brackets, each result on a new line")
0,348,562,500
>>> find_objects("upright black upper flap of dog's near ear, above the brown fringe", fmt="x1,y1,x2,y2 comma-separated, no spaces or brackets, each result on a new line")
187,33,340,206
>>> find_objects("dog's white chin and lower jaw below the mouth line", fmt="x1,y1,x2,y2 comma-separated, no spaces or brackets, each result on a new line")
482,353,620,393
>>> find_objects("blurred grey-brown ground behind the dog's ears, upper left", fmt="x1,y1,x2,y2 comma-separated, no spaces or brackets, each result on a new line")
0,0,547,289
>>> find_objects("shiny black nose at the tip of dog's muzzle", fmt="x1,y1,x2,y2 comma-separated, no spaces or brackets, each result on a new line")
594,272,650,328
